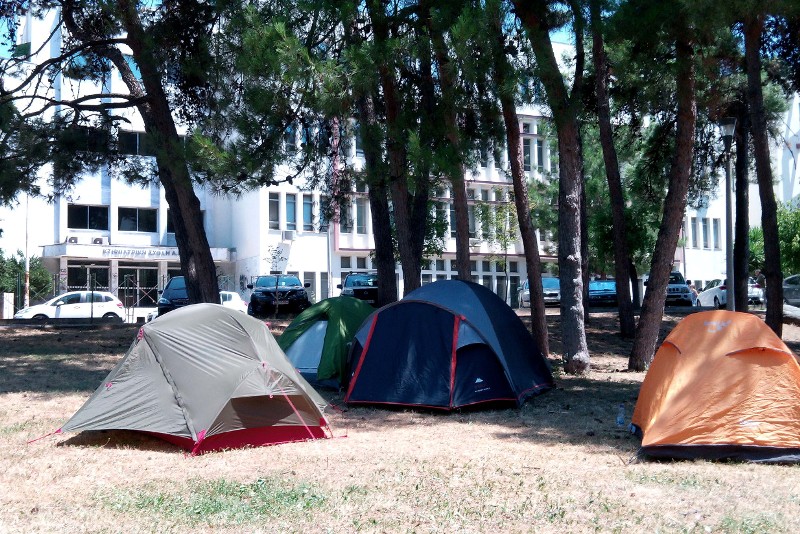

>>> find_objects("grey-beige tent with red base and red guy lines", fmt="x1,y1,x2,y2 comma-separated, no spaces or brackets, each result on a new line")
59,304,329,454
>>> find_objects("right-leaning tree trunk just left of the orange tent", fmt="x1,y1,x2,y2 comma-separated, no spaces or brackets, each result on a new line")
628,29,697,371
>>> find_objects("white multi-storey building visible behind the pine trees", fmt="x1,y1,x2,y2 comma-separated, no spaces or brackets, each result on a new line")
0,12,800,320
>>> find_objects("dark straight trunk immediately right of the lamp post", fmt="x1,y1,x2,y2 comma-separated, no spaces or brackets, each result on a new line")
733,106,750,311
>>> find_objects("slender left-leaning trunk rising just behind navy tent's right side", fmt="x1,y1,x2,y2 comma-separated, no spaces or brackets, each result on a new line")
490,3,550,356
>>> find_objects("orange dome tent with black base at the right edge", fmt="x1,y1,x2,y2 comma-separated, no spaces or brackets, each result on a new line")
632,310,800,462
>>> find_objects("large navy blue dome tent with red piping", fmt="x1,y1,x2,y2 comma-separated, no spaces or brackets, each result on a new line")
345,280,553,410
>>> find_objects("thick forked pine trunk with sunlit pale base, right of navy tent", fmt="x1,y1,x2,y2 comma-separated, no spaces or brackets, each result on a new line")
514,0,590,374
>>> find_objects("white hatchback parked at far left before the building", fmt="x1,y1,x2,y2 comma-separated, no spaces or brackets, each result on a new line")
14,291,125,321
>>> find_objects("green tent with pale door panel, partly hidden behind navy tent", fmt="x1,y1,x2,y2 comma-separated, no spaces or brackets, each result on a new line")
278,297,375,387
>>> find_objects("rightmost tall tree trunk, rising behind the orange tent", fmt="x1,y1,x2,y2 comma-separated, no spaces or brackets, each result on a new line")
744,15,783,337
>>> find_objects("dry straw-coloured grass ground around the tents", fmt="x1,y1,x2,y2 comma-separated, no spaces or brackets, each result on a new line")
0,313,800,532
